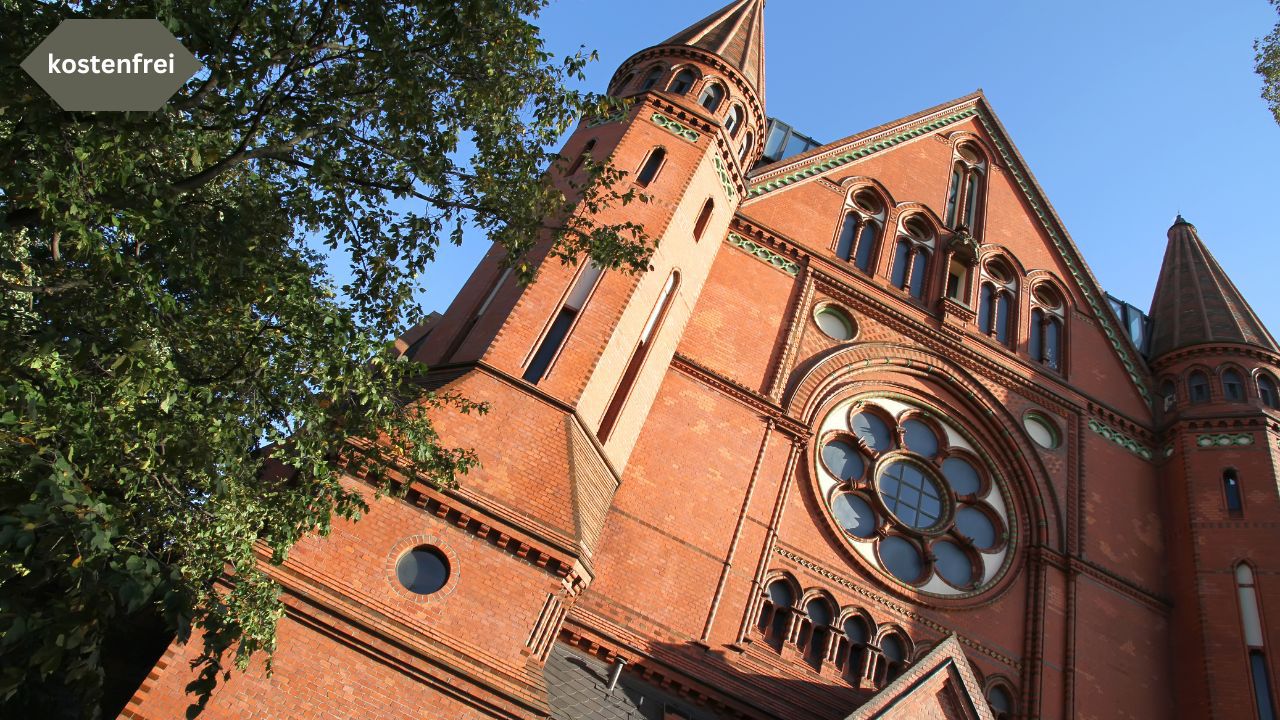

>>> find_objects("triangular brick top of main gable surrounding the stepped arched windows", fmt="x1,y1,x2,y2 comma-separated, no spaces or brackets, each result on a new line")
740,94,1152,418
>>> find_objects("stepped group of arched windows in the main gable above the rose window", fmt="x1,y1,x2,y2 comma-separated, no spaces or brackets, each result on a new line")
831,140,1070,374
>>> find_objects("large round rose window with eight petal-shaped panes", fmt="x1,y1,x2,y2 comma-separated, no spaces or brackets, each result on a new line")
814,397,1015,597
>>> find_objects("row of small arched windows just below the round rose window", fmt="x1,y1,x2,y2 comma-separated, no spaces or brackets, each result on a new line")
755,571,1015,720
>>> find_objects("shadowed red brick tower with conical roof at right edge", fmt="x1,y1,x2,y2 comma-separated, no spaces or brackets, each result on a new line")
1151,215,1280,719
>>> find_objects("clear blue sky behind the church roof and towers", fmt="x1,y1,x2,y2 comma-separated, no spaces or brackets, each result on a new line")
421,0,1280,334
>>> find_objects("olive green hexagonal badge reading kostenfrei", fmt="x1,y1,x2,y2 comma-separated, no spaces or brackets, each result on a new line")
22,19,204,111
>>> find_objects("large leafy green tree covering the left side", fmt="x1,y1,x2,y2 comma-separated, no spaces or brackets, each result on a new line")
0,0,652,714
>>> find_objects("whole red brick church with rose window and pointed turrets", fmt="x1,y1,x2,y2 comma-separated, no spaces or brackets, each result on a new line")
123,0,1280,720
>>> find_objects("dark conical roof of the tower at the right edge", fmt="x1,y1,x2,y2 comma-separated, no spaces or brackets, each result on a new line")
1151,215,1280,359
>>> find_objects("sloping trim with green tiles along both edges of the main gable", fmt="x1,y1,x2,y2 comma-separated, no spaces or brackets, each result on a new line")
746,91,1152,404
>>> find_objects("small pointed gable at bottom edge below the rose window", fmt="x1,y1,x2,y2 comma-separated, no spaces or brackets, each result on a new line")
846,635,995,720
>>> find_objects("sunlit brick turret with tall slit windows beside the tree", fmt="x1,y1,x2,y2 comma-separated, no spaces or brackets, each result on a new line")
417,0,764,468
